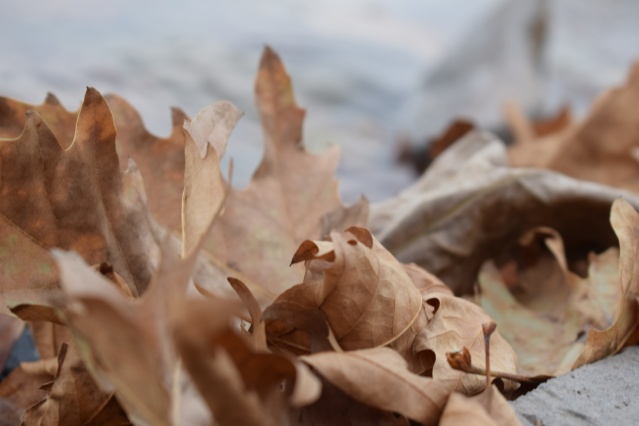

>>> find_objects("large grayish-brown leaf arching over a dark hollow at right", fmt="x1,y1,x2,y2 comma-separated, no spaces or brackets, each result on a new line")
369,132,639,294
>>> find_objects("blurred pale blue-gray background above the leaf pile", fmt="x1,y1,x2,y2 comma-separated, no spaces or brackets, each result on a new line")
0,0,639,202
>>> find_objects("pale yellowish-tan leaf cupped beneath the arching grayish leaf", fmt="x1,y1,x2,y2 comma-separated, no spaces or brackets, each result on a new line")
479,230,621,376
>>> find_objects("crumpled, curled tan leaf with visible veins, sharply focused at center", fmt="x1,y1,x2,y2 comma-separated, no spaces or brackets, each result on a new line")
264,227,428,373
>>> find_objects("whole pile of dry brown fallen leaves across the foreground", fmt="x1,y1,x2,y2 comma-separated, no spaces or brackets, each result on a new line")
0,48,639,425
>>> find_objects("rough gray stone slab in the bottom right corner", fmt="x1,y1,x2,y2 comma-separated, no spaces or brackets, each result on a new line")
513,346,639,426
